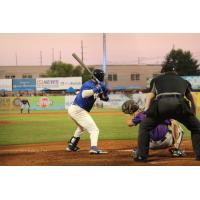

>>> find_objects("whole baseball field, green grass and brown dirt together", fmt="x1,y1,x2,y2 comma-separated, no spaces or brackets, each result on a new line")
0,109,200,166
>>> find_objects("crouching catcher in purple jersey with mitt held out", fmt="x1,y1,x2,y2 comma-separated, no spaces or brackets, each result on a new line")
122,100,184,157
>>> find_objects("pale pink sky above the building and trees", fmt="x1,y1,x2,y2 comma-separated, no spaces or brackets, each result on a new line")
0,33,200,66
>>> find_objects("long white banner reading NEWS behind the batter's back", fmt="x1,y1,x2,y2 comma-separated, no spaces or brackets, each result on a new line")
36,77,82,90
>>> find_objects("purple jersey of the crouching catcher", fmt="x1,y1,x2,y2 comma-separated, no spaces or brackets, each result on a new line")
132,111,171,141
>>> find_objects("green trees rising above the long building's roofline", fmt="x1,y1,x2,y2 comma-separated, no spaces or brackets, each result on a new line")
42,49,200,82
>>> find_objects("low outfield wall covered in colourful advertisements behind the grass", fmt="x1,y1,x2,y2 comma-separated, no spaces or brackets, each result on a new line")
0,92,200,113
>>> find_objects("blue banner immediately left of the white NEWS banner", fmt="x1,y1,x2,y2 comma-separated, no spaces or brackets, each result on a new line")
13,78,36,92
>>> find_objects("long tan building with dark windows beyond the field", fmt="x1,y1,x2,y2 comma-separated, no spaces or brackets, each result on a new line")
0,65,161,90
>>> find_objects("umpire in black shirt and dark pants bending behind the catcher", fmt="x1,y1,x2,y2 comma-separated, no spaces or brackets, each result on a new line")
133,61,200,162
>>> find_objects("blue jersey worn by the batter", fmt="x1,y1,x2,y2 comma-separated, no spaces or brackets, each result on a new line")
74,80,107,112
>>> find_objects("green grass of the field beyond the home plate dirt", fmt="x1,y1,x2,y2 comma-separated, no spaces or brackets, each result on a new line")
0,109,195,145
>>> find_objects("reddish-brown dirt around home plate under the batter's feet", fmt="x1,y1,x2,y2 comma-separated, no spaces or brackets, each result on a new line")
0,140,200,166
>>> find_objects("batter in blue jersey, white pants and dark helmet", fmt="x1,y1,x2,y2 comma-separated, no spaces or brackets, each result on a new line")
66,69,109,154
